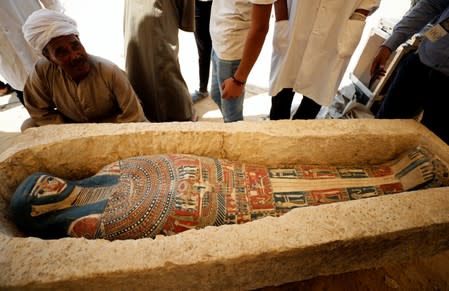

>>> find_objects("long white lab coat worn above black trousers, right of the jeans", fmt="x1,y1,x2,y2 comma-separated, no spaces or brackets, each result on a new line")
270,0,380,106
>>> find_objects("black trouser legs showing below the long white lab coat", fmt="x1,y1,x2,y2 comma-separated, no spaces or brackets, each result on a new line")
270,88,321,120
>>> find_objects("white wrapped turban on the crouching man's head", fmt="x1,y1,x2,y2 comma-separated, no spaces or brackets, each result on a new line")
22,9,79,54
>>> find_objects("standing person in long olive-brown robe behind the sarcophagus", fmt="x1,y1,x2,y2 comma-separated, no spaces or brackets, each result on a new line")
124,0,195,122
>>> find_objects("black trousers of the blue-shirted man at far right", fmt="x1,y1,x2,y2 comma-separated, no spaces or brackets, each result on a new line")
376,52,449,144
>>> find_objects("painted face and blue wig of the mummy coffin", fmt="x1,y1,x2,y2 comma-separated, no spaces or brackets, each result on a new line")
11,173,111,238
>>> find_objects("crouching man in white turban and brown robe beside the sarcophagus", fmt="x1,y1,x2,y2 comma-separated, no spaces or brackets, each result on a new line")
22,9,147,130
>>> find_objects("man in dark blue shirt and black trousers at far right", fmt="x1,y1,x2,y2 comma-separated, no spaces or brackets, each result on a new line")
371,0,449,144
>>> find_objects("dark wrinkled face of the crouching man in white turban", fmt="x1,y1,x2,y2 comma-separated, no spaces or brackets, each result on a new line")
43,34,90,82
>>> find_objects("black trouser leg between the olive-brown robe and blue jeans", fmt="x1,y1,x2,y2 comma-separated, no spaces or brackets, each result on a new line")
194,0,212,92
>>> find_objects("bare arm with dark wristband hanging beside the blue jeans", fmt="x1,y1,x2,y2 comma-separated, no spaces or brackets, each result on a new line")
221,4,273,99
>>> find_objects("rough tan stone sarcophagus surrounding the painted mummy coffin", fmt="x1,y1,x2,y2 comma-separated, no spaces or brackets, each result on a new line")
0,120,449,290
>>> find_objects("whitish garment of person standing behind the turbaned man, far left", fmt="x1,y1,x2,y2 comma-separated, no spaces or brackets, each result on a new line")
0,0,63,91
